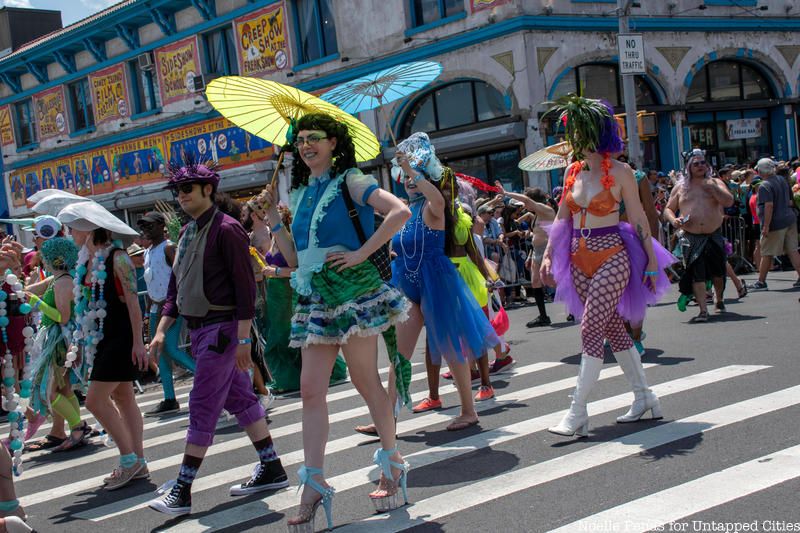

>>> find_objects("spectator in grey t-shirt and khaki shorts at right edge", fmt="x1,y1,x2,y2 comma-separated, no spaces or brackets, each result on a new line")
751,158,800,290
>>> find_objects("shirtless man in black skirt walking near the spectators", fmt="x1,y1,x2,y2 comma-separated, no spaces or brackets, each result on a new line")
664,150,733,323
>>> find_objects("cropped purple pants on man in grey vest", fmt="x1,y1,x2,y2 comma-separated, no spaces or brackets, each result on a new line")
186,321,264,446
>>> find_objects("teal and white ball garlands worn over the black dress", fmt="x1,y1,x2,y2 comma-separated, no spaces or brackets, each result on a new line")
64,245,110,377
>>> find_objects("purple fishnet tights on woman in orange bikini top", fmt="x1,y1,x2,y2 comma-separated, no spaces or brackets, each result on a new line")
571,234,633,359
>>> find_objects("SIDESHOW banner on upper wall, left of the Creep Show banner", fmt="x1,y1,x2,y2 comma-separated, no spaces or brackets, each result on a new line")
155,36,202,105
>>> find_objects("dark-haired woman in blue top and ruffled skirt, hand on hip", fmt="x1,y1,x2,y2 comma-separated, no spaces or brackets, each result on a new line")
261,114,410,532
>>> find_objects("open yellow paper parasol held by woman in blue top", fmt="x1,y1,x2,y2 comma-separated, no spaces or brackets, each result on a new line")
206,76,380,186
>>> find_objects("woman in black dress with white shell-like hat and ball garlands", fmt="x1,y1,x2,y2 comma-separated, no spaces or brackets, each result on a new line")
59,202,149,490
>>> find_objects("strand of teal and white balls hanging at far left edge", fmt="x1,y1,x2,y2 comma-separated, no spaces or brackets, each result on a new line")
0,270,33,476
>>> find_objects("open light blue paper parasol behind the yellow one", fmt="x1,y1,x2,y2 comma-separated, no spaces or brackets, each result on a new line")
321,61,442,146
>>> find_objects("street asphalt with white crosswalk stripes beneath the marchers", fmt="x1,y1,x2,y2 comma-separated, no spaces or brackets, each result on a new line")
4,272,800,533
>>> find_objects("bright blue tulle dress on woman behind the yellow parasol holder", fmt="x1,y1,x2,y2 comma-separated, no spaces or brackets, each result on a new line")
392,197,500,364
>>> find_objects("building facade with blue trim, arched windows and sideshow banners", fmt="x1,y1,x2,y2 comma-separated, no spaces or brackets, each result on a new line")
0,0,800,227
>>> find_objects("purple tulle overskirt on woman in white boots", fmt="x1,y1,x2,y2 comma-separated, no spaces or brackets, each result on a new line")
546,219,678,324
